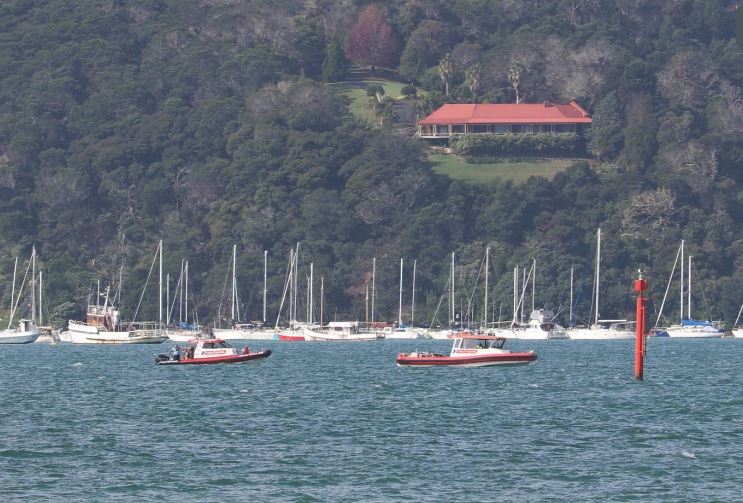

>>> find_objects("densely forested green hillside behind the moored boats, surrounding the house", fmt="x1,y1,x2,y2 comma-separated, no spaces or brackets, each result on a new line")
0,0,743,324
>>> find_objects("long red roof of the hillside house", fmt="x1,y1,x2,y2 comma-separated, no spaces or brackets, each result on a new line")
418,101,592,125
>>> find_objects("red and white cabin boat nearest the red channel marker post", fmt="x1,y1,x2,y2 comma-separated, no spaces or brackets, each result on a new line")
396,333,537,367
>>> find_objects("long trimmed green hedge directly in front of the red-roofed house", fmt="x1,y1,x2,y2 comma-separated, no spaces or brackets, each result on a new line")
449,133,580,156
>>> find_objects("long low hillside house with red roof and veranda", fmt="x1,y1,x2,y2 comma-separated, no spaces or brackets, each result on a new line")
417,101,591,138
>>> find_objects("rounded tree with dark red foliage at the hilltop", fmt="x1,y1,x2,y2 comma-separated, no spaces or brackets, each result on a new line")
346,5,400,70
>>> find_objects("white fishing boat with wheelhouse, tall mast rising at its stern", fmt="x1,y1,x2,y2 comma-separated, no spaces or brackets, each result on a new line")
60,241,168,344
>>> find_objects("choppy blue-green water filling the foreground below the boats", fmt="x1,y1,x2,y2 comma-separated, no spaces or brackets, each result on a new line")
0,339,743,502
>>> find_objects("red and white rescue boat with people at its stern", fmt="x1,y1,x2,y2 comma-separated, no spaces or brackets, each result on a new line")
155,339,271,365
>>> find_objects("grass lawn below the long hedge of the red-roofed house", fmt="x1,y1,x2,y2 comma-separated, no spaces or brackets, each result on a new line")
428,154,577,183
